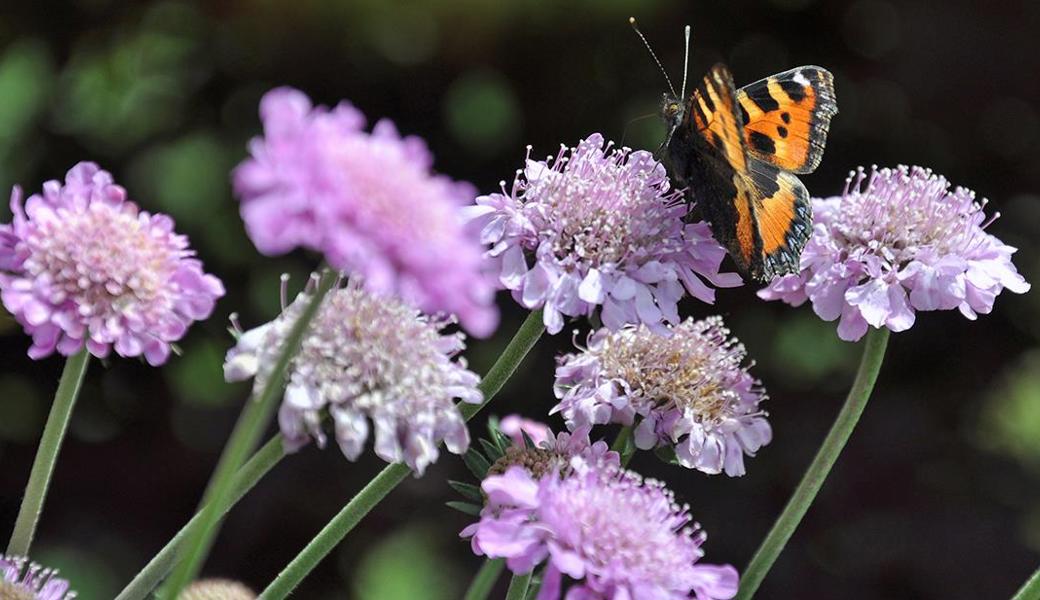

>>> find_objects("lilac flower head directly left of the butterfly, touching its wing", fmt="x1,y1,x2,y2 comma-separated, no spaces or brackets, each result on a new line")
463,133,740,334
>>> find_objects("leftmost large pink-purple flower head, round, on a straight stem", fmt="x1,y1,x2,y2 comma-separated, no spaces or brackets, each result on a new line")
0,162,224,365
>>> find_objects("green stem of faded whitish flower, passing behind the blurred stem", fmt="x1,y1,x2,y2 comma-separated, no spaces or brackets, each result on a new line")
115,434,285,600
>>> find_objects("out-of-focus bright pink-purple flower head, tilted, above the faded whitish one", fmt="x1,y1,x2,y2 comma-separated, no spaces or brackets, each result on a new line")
233,87,498,336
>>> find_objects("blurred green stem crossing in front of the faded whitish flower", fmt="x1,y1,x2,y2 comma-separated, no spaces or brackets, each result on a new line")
161,270,337,598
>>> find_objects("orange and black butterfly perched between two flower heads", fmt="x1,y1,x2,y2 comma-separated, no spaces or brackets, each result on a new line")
633,23,838,283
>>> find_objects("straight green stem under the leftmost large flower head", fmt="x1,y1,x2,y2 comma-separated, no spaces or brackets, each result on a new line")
7,348,90,556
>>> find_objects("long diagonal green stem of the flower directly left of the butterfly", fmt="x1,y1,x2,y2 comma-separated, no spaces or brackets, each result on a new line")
260,310,545,600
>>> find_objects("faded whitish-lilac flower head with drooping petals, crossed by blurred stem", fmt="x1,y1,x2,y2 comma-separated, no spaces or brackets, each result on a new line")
224,279,483,475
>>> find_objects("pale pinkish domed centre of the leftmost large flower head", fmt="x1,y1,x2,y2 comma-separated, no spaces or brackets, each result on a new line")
24,203,183,317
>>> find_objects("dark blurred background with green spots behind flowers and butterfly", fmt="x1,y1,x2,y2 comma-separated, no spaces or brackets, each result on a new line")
0,0,1040,600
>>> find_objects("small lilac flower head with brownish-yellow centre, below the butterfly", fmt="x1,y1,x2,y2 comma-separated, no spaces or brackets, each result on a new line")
552,317,773,476
